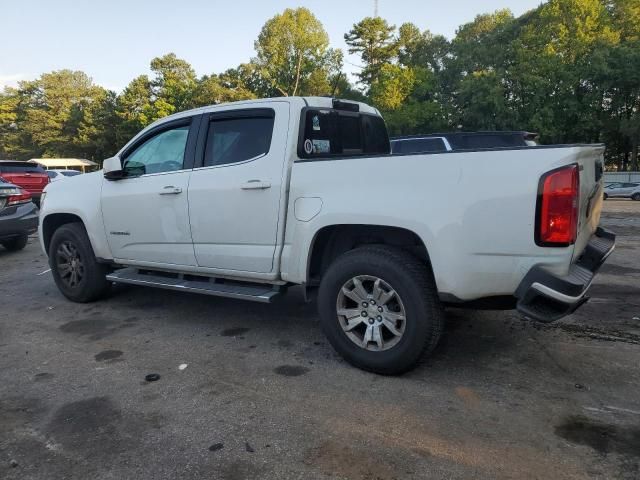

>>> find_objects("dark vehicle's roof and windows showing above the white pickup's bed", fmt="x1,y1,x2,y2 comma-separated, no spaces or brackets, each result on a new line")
391,132,538,154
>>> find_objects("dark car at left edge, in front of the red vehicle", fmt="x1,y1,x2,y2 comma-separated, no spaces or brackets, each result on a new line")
0,177,38,251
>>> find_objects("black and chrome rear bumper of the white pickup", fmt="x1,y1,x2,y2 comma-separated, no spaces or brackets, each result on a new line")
515,227,616,322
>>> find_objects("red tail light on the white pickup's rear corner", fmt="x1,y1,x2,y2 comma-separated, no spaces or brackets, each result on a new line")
536,165,580,247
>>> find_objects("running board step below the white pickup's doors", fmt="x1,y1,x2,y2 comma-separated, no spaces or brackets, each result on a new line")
107,268,280,303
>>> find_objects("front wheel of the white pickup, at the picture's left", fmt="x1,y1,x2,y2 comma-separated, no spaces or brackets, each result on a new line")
49,223,111,303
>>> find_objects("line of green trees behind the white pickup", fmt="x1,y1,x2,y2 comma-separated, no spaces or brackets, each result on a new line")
0,0,640,170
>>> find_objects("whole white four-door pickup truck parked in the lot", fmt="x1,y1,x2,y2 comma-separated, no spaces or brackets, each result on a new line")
40,97,615,374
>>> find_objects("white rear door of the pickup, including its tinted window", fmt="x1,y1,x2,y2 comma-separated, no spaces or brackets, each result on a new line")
189,102,289,273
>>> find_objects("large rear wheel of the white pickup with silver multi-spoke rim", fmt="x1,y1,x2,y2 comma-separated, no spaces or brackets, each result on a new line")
318,246,444,375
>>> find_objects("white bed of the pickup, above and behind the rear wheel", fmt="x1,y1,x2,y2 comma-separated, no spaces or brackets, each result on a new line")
283,145,604,301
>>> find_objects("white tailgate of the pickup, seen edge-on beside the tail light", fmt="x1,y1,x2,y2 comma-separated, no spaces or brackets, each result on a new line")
573,145,604,259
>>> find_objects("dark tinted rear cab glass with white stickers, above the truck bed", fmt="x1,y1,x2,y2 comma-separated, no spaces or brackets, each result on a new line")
298,108,391,159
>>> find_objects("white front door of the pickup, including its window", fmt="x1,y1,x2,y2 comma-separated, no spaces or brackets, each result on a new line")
102,117,198,266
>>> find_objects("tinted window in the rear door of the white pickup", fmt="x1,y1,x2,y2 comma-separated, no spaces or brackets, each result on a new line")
204,113,274,167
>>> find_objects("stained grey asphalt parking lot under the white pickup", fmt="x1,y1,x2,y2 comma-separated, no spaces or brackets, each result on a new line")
0,200,640,480
